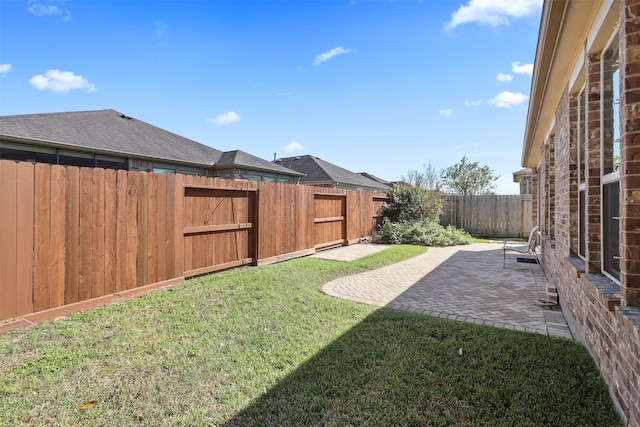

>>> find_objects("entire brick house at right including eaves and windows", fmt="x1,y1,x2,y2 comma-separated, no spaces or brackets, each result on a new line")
522,0,640,426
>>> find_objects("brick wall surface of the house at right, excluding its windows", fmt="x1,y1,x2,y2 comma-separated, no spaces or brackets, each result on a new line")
523,0,640,426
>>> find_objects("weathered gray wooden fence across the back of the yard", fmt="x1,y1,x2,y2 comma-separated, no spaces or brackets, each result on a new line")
441,195,534,237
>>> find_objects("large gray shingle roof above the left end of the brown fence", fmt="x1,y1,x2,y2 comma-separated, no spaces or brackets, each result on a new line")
0,110,222,166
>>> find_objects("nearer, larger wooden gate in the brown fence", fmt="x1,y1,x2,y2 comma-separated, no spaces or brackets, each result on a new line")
183,179,257,277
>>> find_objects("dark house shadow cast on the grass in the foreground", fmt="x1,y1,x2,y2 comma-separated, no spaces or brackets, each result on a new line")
225,309,621,426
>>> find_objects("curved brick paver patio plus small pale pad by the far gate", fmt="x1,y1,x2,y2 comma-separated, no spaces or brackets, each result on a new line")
320,243,573,339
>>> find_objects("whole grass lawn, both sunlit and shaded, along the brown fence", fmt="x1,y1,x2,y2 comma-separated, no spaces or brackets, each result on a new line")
0,246,622,426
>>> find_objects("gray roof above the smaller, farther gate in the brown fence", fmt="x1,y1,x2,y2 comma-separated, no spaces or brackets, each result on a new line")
276,155,390,191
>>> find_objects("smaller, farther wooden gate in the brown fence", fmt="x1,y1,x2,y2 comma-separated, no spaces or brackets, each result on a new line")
313,191,347,249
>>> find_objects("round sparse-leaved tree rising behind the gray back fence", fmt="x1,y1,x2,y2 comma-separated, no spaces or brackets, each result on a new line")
440,157,500,196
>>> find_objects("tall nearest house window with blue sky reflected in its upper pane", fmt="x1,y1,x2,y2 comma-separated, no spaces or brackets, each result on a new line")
600,33,620,280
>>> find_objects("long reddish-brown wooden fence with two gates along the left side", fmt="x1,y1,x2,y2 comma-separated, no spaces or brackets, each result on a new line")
0,160,386,322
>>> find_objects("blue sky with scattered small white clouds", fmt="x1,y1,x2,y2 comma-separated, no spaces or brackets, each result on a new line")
0,0,542,194
